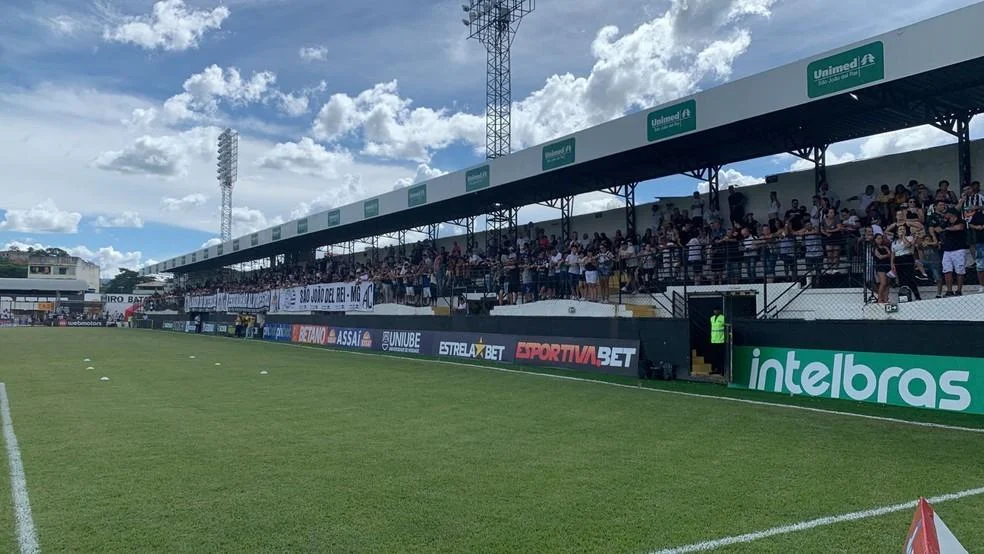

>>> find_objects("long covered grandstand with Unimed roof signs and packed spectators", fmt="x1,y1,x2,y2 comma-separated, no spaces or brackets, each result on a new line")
136,4,984,392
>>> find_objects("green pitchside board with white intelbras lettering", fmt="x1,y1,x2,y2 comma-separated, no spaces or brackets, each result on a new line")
732,346,984,414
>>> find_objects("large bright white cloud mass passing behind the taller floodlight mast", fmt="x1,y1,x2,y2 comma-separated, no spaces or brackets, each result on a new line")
313,0,775,162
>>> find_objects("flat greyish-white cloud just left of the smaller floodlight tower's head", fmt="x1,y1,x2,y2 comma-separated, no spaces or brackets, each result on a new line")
92,127,218,178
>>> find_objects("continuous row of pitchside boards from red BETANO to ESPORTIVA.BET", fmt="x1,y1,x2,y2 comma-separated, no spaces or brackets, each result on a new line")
280,325,639,377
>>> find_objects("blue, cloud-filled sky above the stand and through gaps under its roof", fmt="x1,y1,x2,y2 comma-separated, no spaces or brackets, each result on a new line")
0,0,981,277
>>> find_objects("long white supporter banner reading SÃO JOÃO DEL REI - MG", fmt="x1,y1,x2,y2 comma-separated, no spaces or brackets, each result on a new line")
185,281,375,312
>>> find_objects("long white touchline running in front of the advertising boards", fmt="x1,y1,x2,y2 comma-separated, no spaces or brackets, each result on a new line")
140,329,984,434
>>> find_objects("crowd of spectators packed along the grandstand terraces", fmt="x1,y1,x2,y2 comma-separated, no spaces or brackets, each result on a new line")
154,180,984,308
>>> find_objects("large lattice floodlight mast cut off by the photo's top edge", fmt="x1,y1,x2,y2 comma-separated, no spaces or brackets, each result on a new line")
461,0,536,159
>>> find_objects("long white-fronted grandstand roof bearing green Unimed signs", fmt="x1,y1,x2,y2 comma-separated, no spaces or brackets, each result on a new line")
148,3,984,274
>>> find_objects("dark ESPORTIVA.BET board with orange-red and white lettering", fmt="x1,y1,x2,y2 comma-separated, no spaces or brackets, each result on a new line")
515,337,639,376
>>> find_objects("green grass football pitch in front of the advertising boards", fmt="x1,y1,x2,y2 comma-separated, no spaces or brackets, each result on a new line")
0,329,984,553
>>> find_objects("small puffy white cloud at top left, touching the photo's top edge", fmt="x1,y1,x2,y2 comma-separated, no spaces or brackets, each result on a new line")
103,0,231,51
